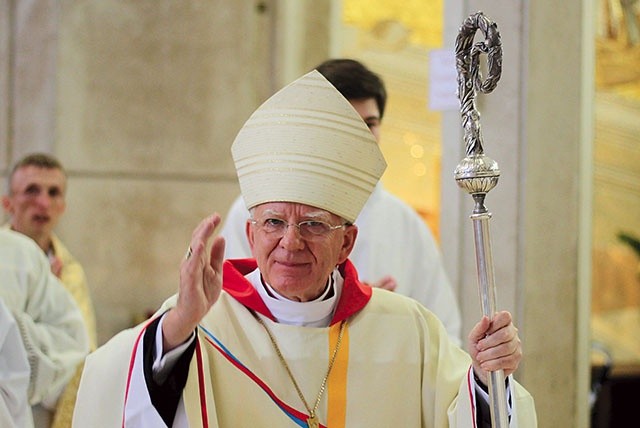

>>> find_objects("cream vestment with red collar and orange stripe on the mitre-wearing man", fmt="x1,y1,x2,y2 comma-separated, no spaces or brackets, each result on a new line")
74,261,537,428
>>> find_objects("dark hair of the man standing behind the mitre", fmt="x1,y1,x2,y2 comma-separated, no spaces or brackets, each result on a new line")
316,58,387,119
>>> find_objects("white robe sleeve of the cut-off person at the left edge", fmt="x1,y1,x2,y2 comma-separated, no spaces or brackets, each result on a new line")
0,230,89,422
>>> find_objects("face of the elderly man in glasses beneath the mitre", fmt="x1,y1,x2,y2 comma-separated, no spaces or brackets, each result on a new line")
247,202,358,301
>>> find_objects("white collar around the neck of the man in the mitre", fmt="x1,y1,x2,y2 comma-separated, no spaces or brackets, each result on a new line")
246,269,344,327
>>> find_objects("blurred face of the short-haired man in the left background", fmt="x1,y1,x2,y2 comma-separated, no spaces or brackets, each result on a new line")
2,165,66,246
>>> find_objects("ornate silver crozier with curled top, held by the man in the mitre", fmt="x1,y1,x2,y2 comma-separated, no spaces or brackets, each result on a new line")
455,12,509,428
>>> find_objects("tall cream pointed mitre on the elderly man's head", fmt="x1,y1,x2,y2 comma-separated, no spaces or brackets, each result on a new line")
231,70,387,222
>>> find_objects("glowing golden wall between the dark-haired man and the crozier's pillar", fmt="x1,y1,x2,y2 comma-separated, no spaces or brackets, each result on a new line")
343,0,444,239
